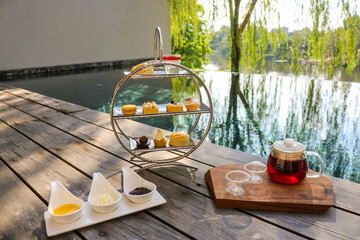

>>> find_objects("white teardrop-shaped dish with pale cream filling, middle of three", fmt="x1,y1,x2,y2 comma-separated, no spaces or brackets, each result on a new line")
88,172,121,213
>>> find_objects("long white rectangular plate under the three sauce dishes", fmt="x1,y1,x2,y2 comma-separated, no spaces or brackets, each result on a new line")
44,191,166,237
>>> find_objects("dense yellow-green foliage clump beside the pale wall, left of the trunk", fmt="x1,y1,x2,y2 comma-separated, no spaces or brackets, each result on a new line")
169,0,211,68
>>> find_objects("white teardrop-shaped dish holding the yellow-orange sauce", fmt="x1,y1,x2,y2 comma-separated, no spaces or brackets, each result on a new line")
48,181,84,224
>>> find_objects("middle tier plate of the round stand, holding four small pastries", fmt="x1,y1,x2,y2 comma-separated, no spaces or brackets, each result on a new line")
114,103,210,118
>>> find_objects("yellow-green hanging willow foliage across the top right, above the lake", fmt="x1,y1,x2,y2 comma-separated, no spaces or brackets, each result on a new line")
169,0,360,76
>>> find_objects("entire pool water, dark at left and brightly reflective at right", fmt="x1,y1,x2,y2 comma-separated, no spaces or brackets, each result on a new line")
8,70,360,183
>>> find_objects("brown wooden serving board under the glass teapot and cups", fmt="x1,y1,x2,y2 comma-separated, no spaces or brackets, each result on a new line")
205,164,333,213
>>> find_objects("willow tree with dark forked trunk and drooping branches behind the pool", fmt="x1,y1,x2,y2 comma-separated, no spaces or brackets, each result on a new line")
169,0,360,73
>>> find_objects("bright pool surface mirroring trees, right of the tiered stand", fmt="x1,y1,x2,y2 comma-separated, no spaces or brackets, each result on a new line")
188,72,360,182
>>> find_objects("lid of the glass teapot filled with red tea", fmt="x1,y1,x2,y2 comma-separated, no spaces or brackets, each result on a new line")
272,138,305,160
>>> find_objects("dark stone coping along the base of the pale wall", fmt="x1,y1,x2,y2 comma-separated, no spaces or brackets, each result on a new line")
0,58,150,81
